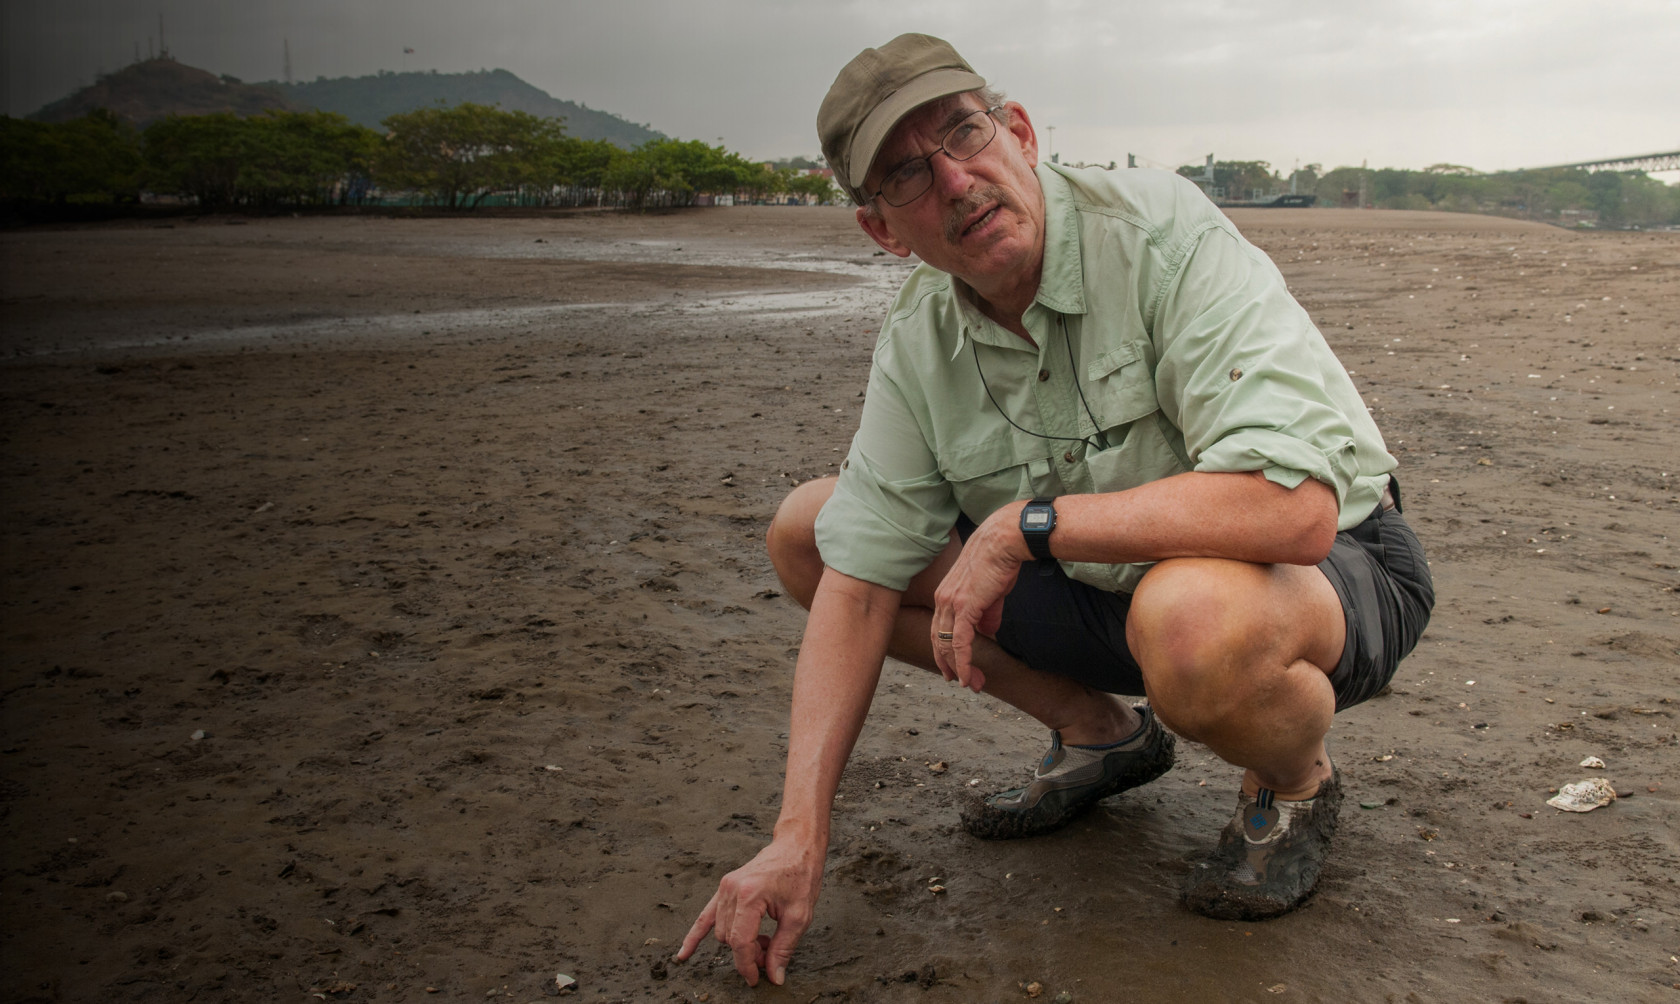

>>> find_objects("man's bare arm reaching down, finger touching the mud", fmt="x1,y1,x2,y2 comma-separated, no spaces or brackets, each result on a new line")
677,569,900,987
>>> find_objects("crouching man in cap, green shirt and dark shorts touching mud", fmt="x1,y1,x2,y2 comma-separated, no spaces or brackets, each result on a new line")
677,35,1435,986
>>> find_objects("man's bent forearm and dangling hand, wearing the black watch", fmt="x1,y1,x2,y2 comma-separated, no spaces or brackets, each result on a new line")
932,472,1337,692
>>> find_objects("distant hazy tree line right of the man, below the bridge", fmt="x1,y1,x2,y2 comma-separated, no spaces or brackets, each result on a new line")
1178,161,1680,227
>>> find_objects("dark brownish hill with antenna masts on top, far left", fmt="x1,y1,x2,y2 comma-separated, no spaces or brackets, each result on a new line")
29,57,299,129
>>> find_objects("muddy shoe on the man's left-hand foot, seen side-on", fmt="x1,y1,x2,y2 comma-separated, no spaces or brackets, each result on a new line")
963,705,1176,839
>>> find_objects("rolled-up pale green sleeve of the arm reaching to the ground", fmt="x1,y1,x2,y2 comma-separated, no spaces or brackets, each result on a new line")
816,359,958,591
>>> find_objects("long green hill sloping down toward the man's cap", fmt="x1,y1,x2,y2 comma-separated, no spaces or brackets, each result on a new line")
265,71,664,149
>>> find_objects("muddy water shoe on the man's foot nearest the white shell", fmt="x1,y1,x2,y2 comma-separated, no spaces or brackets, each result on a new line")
1184,771,1342,920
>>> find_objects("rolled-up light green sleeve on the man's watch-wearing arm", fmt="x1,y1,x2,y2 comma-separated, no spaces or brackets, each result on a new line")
1152,225,1391,504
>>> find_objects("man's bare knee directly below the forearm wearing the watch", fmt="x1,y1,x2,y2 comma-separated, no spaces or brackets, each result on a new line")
1126,557,1282,739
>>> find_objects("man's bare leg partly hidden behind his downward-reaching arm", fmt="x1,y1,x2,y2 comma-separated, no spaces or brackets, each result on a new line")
766,478,1141,745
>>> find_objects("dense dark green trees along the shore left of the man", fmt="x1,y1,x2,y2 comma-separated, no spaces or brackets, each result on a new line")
0,104,845,210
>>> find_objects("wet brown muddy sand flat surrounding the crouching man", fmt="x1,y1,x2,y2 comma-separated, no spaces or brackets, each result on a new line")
0,208,1680,1004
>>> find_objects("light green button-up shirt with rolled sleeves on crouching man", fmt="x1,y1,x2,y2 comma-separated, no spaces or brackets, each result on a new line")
816,165,1394,593
